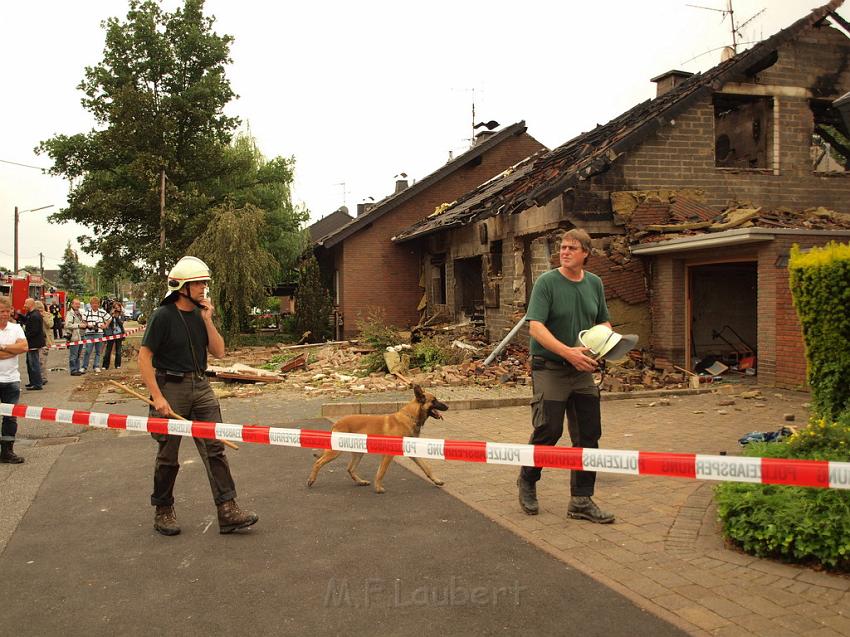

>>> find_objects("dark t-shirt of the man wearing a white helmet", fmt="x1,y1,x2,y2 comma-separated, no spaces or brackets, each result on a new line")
142,303,209,373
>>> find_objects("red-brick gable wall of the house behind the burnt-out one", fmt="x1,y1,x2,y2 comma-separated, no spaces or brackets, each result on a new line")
337,133,542,337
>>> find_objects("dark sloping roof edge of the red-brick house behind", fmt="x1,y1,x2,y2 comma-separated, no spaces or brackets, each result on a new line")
317,121,528,248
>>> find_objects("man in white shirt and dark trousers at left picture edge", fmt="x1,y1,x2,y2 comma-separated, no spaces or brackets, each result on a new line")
0,296,29,464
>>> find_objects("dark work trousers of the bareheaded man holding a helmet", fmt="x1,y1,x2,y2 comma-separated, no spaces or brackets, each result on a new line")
520,362,602,496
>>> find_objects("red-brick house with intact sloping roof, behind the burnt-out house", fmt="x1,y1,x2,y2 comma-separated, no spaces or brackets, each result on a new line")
314,122,543,338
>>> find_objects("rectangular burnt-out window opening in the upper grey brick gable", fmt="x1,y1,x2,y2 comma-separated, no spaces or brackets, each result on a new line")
714,93,773,168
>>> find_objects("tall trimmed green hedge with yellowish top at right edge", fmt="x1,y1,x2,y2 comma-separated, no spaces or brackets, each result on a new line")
789,243,850,419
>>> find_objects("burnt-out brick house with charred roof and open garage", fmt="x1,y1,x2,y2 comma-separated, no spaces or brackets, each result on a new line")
393,0,850,387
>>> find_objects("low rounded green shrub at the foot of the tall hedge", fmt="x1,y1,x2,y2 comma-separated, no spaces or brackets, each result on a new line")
716,413,850,571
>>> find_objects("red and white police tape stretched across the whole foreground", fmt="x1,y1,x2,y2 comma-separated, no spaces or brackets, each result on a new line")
0,403,850,489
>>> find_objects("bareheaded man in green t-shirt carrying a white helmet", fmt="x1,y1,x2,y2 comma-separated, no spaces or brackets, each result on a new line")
517,228,614,524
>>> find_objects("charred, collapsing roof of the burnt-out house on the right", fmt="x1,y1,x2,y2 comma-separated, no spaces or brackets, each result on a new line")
393,0,844,243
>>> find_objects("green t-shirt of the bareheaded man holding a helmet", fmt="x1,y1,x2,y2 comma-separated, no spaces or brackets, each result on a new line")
525,269,608,362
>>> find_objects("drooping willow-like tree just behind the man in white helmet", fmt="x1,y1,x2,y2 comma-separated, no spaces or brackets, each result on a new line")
189,204,279,334
